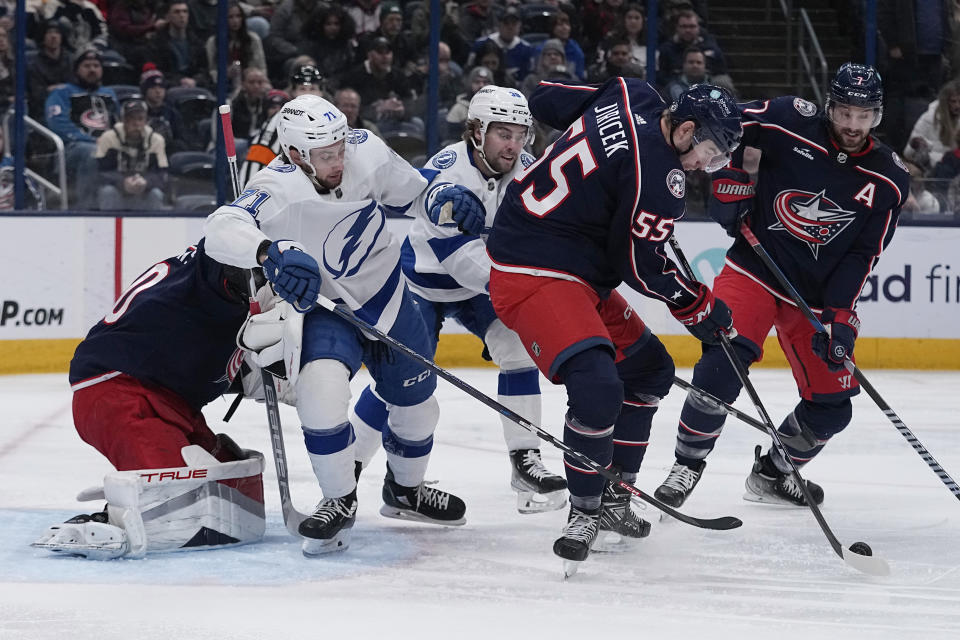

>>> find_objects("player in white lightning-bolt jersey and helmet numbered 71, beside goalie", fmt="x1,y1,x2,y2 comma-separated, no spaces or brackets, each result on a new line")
205,95,465,555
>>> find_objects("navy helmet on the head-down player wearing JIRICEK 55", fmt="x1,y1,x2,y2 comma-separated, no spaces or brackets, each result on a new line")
670,84,743,170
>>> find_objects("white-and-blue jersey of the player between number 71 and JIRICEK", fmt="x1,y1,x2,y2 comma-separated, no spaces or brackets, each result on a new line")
403,140,534,302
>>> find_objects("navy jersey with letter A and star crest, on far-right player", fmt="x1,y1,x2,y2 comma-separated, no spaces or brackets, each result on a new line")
727,96,910,310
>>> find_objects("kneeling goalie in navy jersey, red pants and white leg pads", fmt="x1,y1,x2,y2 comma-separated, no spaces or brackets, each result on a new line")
34,241,265,559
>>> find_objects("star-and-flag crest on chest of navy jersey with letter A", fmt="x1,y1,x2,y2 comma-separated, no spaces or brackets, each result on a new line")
768,189,856,259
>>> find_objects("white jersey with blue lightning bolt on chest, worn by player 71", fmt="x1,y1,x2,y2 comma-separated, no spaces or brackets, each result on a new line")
204,129,427,332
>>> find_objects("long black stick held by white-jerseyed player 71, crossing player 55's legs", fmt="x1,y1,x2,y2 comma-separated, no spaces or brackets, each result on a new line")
317,295,743,530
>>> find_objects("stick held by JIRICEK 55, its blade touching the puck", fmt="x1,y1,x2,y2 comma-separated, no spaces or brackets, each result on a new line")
670,236,890,576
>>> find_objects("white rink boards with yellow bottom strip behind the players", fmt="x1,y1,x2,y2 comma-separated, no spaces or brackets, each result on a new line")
0,214,960,373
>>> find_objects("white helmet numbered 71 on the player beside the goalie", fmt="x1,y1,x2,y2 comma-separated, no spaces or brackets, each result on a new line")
277,94,350,162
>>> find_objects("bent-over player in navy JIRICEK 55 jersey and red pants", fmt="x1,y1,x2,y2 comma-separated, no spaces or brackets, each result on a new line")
487,78,742,562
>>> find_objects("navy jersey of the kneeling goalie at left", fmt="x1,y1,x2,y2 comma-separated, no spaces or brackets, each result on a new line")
70,240,249,411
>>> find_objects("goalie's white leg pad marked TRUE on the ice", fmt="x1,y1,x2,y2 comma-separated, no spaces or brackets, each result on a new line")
32,434,266,560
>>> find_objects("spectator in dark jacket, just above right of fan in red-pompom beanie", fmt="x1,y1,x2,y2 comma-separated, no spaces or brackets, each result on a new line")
152,0,210,87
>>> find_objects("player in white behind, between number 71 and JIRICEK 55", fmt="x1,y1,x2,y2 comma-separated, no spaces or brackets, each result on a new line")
351,86,567,513
